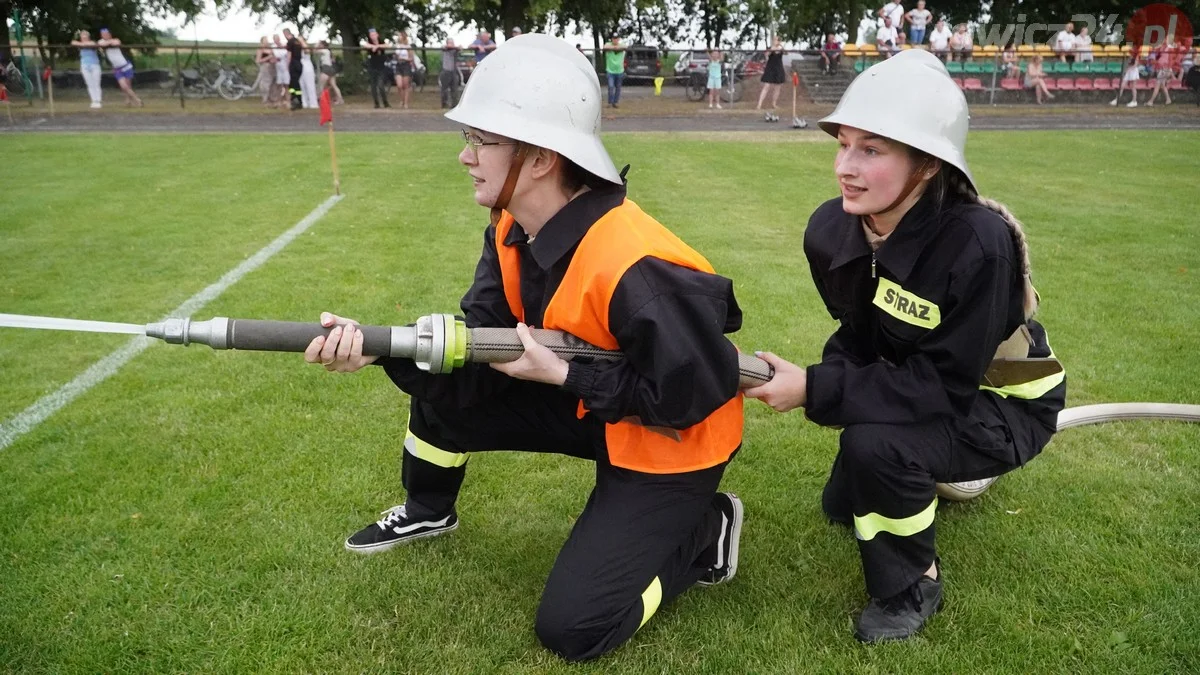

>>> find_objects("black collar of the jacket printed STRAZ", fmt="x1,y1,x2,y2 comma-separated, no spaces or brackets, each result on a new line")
829,192,942,282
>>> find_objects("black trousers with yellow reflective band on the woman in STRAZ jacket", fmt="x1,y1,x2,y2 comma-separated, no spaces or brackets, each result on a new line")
821,392,1051,598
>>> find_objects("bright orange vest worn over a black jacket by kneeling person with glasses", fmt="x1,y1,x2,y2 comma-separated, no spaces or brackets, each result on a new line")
496,199,744,473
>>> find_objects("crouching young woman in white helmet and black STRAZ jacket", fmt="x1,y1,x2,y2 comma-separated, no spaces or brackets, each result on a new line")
745,49,1066,641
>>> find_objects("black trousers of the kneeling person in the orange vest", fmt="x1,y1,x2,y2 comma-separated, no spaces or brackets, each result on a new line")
403,382,728,661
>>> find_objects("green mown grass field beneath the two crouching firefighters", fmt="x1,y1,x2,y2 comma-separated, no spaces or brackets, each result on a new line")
0,131,1200,674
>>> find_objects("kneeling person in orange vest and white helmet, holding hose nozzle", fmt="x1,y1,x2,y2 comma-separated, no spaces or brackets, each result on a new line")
306,35,743,661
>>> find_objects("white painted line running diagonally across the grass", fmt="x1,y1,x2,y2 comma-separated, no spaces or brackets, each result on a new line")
0,196,342,450
